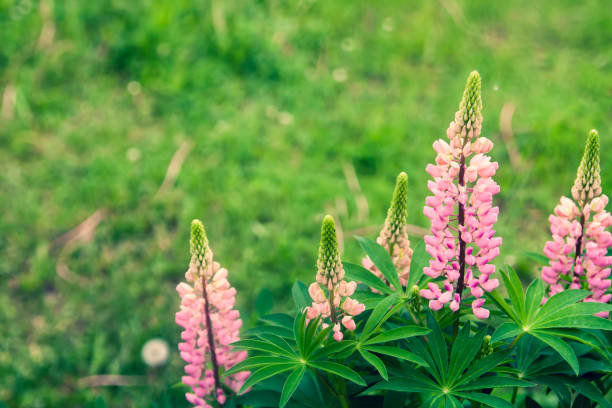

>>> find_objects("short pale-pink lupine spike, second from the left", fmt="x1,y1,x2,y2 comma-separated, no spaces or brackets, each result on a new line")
306,215,365,341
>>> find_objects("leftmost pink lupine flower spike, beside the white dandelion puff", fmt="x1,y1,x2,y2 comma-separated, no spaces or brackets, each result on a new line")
176,220,249,408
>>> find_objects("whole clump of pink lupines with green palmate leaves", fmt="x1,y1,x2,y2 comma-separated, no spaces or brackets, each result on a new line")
176,72,612,408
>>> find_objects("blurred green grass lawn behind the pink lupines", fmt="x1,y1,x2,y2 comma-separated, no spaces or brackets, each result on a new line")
0,0,612,407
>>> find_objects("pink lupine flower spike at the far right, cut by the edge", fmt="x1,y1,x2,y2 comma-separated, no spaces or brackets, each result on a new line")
542,130,612,317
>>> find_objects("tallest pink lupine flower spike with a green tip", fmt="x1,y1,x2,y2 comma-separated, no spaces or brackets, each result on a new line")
421,71,502,319
